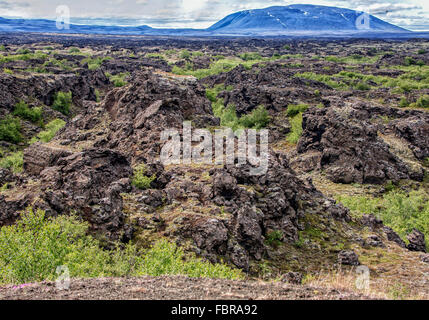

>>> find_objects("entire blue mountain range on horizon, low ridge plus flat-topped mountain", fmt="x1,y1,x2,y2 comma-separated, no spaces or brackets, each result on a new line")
0,5,422,37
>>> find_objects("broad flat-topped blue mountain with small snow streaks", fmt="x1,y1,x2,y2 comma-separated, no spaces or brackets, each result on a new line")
208,4,408,34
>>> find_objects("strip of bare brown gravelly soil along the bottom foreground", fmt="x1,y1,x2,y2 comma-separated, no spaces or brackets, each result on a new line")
0,276,371,300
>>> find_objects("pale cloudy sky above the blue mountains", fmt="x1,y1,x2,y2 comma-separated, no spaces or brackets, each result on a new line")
0,0,429,31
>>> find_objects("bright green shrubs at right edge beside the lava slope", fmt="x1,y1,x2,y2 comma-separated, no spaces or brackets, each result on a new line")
337,190,429,246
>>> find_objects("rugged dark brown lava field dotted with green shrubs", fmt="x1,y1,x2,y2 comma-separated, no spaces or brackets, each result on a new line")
0,34,429,299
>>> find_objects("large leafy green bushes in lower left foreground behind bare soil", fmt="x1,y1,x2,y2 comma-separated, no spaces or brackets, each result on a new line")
0,209,243,284
